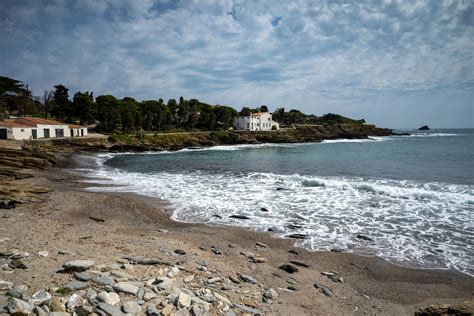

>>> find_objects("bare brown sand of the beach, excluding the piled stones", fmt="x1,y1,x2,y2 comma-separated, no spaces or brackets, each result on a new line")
0,152,474,315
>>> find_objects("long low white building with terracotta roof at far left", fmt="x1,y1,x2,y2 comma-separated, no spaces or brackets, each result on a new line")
0,117,87,140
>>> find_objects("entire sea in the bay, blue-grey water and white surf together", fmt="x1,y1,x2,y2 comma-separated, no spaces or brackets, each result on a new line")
87,129,474,275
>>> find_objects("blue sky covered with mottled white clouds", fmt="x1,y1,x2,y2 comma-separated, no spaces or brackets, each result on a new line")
0,0,474,128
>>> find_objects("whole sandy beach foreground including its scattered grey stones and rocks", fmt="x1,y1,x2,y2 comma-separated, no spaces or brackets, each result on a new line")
0,139,474,316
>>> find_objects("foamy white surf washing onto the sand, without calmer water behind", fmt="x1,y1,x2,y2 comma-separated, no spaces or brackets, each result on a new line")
84,163,474,275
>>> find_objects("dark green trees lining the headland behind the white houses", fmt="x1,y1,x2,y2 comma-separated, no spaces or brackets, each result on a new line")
0,76,365,133
